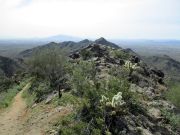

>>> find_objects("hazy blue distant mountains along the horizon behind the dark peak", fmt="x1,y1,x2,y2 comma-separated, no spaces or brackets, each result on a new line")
0,34,180,46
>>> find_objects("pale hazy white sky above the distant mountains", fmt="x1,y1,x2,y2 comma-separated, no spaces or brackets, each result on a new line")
0,0,180,39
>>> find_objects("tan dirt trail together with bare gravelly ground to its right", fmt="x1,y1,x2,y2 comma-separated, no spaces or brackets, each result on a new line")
0,83,72,135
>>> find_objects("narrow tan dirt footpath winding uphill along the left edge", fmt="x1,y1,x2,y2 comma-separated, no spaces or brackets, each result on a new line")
0,83,31,135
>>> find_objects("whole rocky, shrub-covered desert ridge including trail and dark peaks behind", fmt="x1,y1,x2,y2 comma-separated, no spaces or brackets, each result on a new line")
0,38,180,135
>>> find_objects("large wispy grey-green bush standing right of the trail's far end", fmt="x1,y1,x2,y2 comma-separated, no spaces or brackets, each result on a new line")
27,47,66,87
